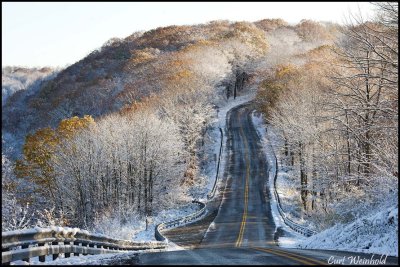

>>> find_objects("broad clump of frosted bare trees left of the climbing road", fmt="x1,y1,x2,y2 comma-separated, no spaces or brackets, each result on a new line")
54,112,184,227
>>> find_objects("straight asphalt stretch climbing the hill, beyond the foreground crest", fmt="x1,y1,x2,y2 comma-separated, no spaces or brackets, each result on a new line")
201,105,275,248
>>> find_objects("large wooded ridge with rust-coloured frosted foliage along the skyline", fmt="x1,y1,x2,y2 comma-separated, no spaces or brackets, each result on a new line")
2,19,337,157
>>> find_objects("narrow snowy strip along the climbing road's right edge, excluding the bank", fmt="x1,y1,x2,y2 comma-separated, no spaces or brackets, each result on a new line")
252,112,305,248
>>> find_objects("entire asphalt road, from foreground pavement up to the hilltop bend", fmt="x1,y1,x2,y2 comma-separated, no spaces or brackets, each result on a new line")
115,104,398,265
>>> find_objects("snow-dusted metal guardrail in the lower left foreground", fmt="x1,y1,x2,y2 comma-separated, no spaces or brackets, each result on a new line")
1,227,167,265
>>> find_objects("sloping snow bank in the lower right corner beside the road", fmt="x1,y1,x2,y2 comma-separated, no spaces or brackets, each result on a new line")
297,205,399,257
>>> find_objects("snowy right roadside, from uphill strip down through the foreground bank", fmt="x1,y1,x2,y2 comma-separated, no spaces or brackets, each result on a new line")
252,112,398,257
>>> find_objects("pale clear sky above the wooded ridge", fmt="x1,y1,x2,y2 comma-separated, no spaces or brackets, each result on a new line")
2,2,373,67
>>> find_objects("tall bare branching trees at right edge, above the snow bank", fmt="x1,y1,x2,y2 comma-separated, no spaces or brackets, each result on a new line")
332,5,398,183
